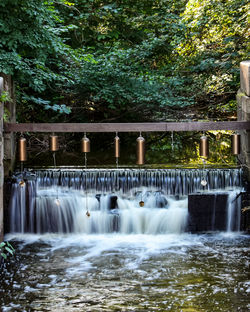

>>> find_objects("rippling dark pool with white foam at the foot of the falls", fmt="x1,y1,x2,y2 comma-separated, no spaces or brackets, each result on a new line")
0,234,250,312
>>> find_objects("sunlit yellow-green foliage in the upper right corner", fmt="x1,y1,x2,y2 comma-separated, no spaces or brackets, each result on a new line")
176,0,250,118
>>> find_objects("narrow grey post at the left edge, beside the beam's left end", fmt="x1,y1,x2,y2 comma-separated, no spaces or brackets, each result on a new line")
0,77,4,242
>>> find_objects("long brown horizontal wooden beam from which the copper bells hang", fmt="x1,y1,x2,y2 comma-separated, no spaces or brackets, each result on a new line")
4,121,250,132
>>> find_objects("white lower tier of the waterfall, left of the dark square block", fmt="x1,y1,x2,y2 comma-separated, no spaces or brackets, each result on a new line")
10,187,187,234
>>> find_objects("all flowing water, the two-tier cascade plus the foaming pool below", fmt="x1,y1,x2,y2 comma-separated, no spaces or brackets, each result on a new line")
0,169,250,312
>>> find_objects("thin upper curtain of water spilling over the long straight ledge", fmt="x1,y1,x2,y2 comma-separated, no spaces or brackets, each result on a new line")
35,169,242,195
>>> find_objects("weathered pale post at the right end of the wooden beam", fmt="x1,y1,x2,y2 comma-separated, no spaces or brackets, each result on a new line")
237,61,250,183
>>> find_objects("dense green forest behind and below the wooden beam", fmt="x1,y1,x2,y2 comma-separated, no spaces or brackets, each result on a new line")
0,0,250,163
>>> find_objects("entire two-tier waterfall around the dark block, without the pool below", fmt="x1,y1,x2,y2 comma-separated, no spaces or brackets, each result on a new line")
9,169,242,234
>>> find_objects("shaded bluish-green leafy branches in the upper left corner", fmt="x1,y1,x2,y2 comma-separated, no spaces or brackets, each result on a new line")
0,0,73,112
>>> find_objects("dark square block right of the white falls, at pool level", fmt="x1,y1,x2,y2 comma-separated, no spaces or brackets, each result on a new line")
187,193,228,233
